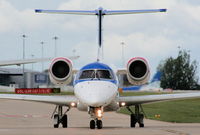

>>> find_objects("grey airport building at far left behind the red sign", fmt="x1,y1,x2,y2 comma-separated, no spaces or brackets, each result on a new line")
0,68,51,88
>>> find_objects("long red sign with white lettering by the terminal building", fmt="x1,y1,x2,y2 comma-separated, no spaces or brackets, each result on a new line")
15,88,53,94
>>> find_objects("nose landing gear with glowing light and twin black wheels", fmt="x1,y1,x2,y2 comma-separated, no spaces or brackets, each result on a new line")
88,107,103,129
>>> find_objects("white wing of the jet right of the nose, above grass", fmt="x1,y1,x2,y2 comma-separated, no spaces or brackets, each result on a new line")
117,92,200,106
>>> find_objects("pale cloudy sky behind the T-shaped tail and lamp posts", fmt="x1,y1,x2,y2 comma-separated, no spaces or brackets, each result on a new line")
0,0,200,77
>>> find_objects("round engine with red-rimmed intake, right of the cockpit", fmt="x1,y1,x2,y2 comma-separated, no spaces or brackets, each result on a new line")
127,57,150,85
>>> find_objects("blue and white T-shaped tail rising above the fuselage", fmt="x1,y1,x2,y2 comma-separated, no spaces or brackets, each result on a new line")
35,7,167,61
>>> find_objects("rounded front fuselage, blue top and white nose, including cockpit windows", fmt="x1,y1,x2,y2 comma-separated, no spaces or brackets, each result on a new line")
74,62,118,107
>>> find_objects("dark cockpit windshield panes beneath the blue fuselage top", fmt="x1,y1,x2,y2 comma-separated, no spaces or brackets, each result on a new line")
79,70,113,79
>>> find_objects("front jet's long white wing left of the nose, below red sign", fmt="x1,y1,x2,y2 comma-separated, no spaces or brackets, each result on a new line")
0,94,78,106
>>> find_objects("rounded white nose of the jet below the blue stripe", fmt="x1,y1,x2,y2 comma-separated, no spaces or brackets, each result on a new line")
75,81,117,107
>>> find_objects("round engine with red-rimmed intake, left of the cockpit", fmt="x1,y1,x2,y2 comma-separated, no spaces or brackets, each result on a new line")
49,57,72,85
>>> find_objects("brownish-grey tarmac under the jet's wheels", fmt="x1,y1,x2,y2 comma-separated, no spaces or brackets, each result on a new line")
0,100,200,135
